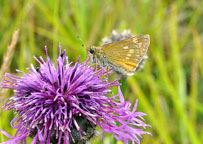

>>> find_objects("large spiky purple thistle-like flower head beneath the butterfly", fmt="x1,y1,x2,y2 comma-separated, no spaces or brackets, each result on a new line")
0,46,150,144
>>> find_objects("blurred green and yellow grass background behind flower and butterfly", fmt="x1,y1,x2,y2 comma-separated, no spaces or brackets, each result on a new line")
0,0,203,144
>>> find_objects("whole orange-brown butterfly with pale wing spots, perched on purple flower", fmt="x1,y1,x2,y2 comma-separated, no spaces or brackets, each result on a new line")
89,34,150,76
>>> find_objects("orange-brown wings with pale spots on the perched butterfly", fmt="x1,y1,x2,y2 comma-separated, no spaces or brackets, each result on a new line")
102,35,150,72
